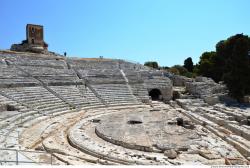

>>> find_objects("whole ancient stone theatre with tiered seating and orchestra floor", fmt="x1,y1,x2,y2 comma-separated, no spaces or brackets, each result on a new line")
0,51,250,165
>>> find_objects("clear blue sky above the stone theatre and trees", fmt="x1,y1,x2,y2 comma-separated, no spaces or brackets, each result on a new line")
0,0,250,66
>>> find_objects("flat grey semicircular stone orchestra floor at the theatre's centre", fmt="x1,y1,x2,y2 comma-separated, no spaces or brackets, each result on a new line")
95,102,202,155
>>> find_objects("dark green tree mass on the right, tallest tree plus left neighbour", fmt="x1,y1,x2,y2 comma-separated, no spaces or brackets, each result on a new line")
195,34,250,101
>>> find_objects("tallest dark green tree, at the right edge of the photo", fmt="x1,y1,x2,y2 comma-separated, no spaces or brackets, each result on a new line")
221,34,250,101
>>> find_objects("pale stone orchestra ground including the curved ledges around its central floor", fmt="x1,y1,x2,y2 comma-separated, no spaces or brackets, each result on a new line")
14,102,249,165
